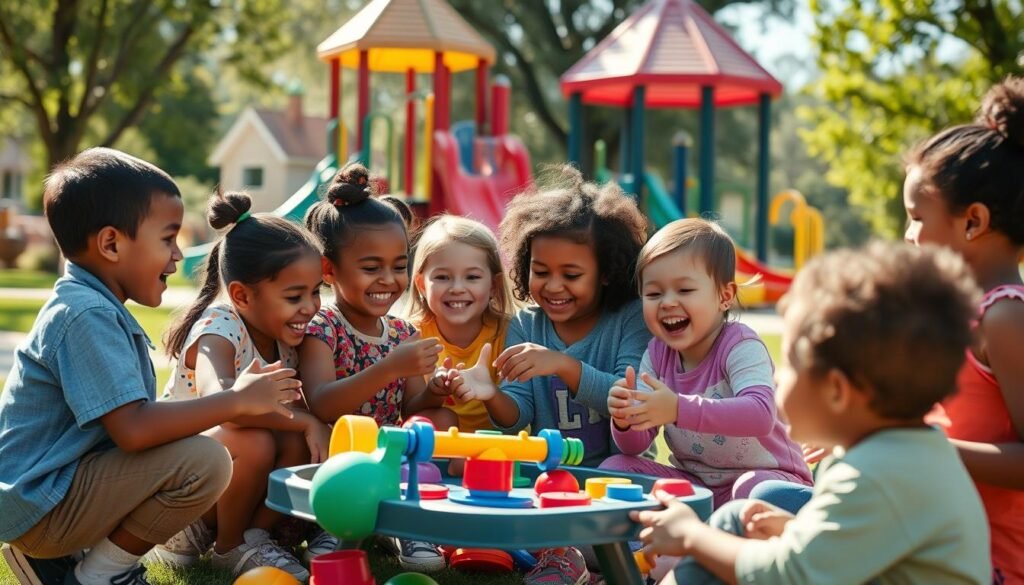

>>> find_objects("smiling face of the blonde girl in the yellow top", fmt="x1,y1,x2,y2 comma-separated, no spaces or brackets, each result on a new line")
416,242,496,341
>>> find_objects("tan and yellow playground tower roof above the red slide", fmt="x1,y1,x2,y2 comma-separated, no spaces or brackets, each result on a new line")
316,0,495,73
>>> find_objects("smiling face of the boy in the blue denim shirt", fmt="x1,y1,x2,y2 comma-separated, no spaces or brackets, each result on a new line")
112,193,184,306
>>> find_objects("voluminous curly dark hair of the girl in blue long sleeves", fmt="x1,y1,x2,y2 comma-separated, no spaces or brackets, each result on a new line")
499,165,647,310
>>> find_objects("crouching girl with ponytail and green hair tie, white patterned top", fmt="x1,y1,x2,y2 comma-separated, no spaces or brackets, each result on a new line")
157,188,329,581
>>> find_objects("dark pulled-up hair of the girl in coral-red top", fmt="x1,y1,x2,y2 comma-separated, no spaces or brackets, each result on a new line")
907,77,1024,246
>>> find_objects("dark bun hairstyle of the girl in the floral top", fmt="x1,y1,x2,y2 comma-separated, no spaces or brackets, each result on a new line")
306,163,408,263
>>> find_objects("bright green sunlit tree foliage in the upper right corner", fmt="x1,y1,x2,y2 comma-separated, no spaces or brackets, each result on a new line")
801,0,1024,236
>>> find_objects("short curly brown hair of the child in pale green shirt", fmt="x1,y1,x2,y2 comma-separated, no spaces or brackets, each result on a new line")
779,242,980,419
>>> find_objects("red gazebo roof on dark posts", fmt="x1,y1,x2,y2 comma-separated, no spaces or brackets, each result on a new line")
561,0,782,108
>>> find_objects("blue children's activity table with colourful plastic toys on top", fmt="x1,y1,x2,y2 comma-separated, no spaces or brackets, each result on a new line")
267,416,712,585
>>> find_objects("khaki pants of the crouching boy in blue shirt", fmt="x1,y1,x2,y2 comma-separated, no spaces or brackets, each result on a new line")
11,436,231,558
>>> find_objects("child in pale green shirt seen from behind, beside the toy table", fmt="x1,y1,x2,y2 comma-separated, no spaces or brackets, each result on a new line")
631,243,991,585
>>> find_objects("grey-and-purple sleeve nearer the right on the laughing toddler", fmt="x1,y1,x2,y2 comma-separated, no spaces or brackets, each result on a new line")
676,339,776,436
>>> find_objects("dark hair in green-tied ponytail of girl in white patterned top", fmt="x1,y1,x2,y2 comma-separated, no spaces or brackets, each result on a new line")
164,190,321,358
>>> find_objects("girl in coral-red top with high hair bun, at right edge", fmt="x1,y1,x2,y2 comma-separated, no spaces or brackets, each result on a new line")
903,78,1024,585
